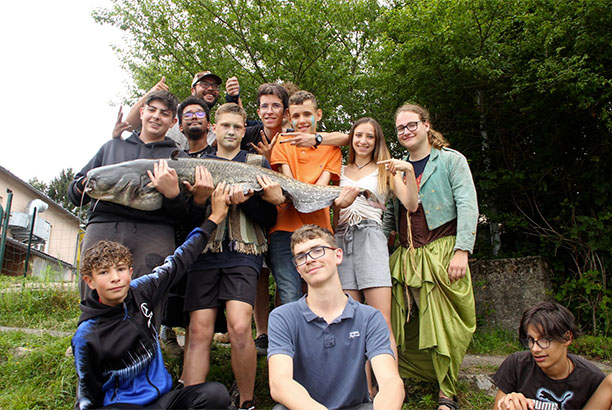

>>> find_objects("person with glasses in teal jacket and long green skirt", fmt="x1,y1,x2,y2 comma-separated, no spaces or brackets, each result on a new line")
383,104,478,410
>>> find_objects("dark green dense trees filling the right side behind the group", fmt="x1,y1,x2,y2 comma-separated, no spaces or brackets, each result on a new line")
373,0,612,330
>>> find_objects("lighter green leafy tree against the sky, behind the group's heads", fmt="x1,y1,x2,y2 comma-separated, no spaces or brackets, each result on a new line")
94,0,381,129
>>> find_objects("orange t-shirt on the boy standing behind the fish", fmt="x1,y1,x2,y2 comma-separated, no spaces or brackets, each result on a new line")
270,142,342,233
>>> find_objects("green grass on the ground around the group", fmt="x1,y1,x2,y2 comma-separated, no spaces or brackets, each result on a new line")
0,276,612,410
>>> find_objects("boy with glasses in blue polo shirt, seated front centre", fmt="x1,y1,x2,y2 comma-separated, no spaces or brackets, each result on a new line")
268,225,404,410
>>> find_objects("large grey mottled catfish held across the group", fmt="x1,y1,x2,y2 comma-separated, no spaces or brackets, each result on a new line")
85,158,383,213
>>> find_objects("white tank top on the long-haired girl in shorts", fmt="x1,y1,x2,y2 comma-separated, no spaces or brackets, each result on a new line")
338,165,387,225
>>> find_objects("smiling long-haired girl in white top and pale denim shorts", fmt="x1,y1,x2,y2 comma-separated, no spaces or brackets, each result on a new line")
334,117,397,357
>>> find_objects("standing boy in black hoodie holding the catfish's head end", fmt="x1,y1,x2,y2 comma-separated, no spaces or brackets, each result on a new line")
68,91,210,310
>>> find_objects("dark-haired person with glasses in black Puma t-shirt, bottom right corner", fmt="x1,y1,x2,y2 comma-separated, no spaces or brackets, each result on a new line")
493,302,610,410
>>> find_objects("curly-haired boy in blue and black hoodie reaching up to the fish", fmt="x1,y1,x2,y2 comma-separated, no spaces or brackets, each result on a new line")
72,183,229,410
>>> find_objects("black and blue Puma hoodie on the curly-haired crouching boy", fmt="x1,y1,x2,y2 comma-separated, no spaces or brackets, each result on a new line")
72,220,217,410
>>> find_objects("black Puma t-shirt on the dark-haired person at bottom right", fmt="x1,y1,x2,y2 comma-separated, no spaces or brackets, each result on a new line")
493,352,605,410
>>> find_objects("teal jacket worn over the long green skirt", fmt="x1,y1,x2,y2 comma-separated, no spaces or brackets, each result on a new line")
383,148,478,253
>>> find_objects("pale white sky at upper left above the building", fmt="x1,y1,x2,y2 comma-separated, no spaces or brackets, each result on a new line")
0,0,131,182
